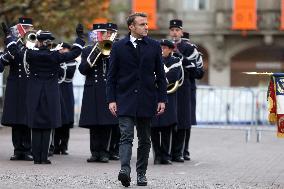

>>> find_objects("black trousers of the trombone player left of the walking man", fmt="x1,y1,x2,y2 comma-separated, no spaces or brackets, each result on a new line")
90,125,112,157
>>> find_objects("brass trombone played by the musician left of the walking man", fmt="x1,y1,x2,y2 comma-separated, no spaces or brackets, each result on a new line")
87,32,117,67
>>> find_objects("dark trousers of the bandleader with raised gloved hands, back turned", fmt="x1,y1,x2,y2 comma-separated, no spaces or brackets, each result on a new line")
32,129,51,162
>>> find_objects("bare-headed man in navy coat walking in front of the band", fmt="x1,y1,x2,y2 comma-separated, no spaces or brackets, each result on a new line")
107,13,167,186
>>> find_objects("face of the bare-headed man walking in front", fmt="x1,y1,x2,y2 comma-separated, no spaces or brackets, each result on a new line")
129,16,148,38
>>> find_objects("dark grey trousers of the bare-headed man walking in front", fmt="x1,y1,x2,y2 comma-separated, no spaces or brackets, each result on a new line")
118,116,151,173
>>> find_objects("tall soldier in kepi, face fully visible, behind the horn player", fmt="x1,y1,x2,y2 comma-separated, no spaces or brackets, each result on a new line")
169,19,202,162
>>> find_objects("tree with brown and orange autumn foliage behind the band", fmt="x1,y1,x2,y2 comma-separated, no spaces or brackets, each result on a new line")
0,0,109,44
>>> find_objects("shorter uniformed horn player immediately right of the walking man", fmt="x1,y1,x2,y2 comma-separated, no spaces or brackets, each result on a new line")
151,39,182,164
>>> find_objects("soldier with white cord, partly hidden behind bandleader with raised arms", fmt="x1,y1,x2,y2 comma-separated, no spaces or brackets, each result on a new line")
53,43,77,155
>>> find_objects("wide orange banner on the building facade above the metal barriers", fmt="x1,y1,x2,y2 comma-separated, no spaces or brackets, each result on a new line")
232,0,257,30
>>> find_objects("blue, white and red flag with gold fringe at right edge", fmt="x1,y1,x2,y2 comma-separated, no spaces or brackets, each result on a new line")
267,73,284,138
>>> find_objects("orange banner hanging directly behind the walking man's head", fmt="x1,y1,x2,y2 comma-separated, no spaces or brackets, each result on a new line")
132,0,158,30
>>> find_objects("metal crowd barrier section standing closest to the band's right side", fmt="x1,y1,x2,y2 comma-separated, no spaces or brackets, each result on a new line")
194,86,255,141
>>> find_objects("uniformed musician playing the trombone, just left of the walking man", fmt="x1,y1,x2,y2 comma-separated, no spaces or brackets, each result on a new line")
79,24,118,163
